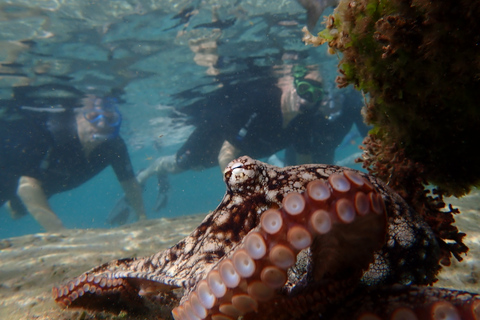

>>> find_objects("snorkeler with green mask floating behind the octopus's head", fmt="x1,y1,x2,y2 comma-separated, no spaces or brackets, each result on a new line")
109,68,368,221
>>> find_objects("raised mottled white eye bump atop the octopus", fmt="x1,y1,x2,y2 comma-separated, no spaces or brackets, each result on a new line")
223,156,261,192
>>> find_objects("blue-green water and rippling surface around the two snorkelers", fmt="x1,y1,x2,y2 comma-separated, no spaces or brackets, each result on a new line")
0,0,362,238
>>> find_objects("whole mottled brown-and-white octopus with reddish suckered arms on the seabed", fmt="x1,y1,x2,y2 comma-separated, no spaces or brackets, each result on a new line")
53,156,480,320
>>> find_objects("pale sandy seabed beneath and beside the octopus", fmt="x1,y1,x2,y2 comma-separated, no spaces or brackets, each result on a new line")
0,191,480,320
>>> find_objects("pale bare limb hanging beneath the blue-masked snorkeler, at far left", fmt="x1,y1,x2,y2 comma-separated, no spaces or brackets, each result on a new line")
17,176,65,231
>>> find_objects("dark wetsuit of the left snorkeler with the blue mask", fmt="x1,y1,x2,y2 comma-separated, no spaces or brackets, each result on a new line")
0,110,135,209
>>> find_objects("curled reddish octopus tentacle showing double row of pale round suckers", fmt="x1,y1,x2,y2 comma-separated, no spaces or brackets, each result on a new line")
173,171,386,320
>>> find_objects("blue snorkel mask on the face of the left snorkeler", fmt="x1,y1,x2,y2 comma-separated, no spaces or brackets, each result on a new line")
83,98,122,140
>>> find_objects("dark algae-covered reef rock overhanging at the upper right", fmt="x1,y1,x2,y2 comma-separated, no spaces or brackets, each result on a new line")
304,0,480,264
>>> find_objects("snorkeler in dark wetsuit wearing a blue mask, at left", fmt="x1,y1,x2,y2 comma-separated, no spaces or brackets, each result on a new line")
0,91,146,231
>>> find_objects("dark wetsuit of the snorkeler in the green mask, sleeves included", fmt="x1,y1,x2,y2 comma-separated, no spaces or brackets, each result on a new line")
177,79,369,170
